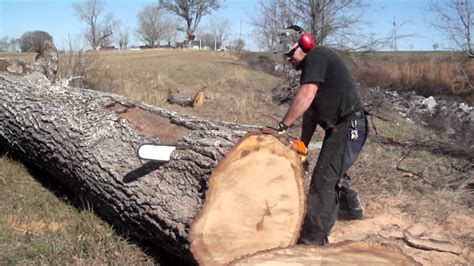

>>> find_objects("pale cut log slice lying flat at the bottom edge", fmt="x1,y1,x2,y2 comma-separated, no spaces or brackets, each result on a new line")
230,242,418,265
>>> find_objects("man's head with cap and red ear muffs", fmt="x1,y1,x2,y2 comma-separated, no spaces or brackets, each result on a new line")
275,25,314,68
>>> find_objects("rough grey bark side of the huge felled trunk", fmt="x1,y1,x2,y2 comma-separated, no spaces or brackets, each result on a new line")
0,74,260,261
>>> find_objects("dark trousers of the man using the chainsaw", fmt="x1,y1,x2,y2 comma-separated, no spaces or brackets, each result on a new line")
299,115,368,245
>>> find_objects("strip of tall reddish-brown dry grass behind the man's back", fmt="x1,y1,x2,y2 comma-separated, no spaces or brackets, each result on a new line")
352,52,474,101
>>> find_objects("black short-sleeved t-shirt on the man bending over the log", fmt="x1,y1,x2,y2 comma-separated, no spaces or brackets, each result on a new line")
300,46,363,129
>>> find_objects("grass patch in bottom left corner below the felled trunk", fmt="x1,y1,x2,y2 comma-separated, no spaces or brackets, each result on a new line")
0,155,154,265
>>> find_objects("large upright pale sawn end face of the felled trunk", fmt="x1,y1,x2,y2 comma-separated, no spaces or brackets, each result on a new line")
190,135,305,265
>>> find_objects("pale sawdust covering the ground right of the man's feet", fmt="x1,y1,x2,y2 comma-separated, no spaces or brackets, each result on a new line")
329,200,474,265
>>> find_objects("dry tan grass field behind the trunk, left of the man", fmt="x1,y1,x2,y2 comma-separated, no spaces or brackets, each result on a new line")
90,50,281,125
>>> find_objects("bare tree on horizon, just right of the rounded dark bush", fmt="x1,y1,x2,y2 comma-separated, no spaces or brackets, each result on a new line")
73,0,118,50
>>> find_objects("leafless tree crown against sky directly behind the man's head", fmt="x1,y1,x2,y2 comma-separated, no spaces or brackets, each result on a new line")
253,0,394,50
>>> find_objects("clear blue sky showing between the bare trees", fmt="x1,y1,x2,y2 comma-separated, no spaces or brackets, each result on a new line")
0,0,445,50
